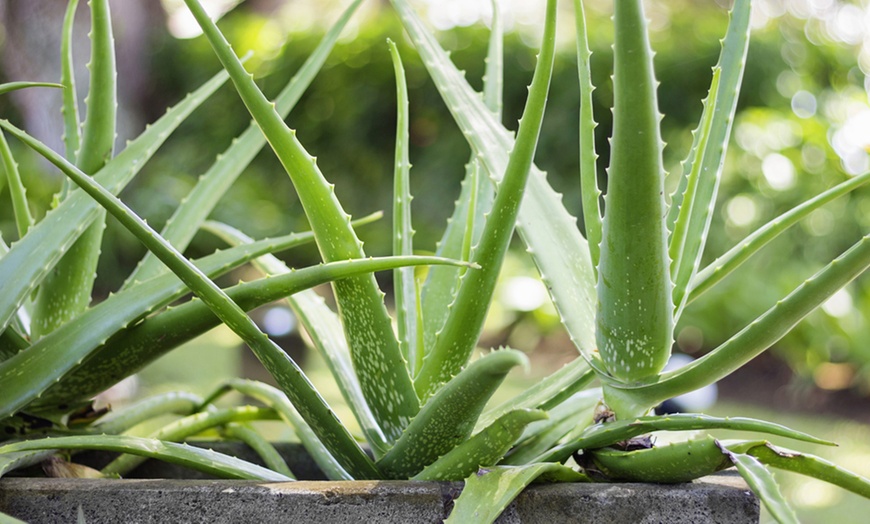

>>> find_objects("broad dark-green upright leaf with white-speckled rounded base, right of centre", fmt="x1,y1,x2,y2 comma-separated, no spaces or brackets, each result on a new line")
596,0,674,388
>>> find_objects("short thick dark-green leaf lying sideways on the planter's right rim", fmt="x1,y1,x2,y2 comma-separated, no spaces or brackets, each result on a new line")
584,436,731,484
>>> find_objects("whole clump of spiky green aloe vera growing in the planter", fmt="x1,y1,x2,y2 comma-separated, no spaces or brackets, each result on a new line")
0,0,870,522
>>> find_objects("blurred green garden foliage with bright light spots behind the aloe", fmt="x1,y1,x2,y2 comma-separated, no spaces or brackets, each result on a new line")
0,1,870,394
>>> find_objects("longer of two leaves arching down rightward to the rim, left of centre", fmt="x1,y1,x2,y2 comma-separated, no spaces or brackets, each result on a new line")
227,379,353,480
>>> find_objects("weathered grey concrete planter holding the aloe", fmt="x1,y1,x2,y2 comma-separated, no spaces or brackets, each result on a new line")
0,446,759,524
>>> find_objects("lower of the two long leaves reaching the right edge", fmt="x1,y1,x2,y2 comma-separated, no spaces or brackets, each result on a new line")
604,232,870,408
